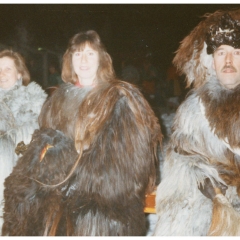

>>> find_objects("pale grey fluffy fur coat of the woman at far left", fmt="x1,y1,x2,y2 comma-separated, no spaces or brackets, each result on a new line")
0,82,47,232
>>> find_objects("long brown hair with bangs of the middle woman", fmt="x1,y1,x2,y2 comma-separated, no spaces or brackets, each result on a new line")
62,30,115,83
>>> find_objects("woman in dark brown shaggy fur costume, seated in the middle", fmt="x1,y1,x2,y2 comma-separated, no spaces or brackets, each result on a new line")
3,30,162,236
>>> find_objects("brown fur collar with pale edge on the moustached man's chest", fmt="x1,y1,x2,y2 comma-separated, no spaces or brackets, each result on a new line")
197,78,240,148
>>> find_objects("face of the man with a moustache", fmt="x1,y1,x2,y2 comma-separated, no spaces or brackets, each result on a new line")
213,45,240,89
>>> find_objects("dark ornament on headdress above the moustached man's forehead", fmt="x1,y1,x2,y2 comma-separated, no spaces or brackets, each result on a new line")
206,13,240,54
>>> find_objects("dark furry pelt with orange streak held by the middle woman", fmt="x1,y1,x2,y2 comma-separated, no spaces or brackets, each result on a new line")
2,129,78,236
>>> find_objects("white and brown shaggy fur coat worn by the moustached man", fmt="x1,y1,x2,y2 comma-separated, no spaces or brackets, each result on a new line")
154,77,240,236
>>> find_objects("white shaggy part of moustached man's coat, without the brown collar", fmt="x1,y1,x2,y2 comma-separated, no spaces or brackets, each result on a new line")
155,79,240,236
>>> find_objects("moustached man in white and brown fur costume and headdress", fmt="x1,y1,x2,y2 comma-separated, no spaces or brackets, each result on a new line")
154,7,240,236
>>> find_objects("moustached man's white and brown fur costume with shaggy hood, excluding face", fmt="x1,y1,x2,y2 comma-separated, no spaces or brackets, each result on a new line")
154,11,240,236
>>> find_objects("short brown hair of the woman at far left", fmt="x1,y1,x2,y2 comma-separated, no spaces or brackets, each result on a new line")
0,49,30,86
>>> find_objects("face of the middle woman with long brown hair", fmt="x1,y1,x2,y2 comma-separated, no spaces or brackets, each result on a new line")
72,44,99,85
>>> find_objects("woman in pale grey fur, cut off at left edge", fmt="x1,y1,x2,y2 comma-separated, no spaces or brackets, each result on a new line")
0,49,47,233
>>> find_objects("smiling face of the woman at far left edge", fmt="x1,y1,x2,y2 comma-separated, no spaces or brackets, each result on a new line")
0,57,21,89
